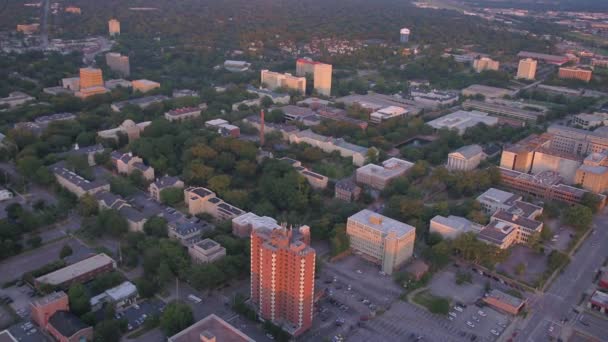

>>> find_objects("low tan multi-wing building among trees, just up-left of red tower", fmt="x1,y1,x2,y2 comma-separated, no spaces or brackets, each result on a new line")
184,187,245,221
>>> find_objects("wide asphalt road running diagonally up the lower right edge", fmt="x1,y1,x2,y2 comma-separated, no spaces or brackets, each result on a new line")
516,210,608,341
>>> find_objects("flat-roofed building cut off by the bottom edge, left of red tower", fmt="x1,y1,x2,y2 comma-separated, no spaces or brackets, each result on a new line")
167,314,255,342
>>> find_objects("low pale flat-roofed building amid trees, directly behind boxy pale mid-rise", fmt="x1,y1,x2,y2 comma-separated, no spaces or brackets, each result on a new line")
356,158,414,190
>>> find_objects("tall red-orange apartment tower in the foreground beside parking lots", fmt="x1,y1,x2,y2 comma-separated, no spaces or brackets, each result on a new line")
251,226,316,336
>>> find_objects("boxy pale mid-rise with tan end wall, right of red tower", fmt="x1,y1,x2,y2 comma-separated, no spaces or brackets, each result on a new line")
346,209,416,274
